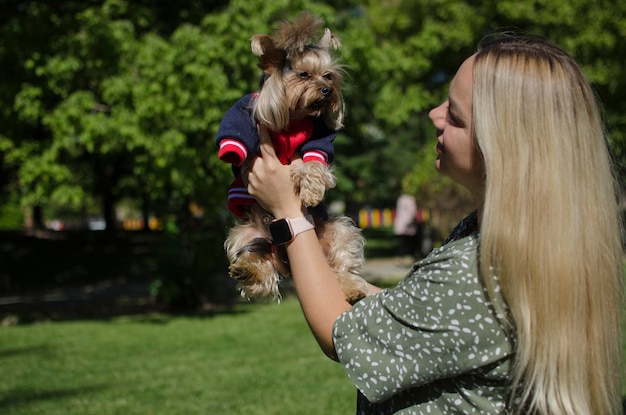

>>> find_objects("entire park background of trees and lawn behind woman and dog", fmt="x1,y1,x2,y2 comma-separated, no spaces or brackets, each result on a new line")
0,0,626,414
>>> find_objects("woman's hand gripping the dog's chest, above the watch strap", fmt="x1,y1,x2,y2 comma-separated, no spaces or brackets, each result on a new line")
242,126,303,218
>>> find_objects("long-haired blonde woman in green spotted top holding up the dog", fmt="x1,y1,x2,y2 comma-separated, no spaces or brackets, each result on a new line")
248,37,623,415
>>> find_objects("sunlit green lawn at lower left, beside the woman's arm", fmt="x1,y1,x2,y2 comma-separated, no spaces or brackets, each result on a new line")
0,299,355,415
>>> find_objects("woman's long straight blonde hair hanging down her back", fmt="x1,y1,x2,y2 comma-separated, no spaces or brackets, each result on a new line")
473,37,623,415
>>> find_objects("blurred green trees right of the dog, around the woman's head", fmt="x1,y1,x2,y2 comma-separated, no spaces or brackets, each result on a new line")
337,0,626,214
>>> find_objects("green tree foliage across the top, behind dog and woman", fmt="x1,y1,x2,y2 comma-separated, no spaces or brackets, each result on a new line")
0,0,626,306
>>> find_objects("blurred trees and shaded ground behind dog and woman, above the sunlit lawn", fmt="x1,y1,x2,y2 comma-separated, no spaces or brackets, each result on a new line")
0,0,626,310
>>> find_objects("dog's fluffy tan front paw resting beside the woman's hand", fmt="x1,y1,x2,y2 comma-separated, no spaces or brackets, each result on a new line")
291,161,337,206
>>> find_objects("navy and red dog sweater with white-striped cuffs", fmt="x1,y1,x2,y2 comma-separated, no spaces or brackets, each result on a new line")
215,93,336,218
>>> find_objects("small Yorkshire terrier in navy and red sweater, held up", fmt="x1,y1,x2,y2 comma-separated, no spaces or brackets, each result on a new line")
216,12,367,304
